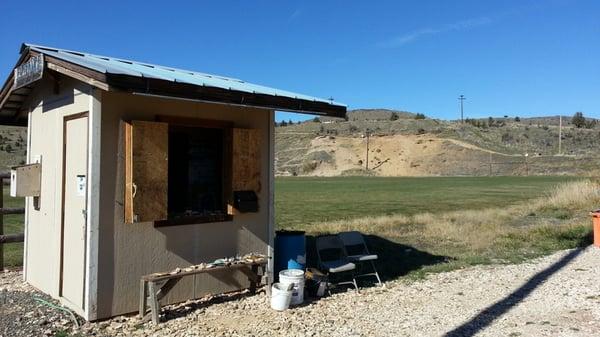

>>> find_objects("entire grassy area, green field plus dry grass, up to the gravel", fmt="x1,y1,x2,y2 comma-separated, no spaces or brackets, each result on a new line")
275,176,600,280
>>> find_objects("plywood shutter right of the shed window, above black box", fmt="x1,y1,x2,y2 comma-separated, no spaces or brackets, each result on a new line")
231,128,261,192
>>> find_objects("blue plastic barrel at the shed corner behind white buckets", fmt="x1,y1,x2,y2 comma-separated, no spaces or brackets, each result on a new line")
275,231,306,275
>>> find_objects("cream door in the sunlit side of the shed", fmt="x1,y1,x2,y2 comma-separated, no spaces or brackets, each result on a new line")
60,113,88,308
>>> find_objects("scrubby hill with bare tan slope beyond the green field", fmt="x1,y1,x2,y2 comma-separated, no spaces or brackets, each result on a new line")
275,109,600,176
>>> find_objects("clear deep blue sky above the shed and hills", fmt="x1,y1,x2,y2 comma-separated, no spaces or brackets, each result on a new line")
0,0,600,120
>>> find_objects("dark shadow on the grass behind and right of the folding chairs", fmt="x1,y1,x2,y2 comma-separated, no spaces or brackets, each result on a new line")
306,235,451,281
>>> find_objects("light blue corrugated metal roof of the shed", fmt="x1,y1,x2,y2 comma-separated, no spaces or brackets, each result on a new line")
23,44,345,106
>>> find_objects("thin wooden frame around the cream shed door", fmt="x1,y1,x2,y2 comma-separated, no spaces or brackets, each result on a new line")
58,111,90,310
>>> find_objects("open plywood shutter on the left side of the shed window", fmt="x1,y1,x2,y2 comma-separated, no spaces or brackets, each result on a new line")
124,121,169,223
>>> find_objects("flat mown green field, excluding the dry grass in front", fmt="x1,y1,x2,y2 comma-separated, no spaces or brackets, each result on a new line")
275,176,576,229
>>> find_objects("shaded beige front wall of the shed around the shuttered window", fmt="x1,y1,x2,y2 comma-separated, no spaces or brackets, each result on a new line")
97,92,272,318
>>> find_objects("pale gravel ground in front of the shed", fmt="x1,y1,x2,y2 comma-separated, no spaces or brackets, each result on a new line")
0,247,600,337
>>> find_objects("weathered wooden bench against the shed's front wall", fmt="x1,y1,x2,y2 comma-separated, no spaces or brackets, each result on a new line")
139,259,267,324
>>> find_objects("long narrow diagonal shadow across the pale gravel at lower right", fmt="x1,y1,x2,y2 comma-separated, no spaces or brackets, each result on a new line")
444,248,583,337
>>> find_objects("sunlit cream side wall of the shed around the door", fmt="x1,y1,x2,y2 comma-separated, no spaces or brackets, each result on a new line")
25,77,89,314
